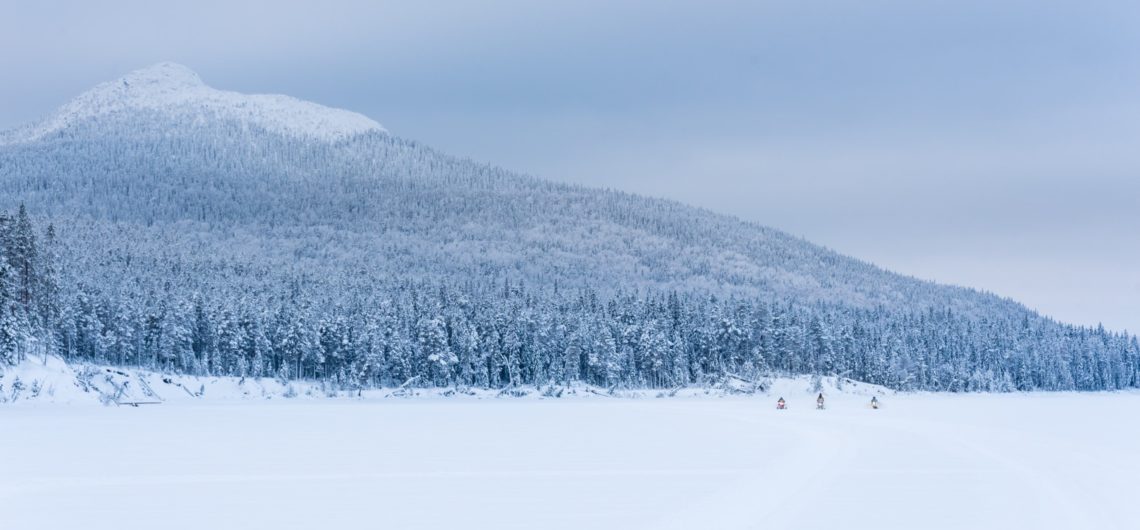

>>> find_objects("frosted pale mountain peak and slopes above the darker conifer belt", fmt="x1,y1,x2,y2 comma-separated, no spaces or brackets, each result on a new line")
0,68,984,311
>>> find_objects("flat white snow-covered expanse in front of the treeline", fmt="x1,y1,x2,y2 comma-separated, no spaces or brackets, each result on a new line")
0,373,1140,530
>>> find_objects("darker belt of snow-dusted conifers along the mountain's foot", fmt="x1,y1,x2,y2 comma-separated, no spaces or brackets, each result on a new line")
0,200,1140,392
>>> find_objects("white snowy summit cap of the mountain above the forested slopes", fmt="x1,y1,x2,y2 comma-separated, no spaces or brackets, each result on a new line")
0,63,384,142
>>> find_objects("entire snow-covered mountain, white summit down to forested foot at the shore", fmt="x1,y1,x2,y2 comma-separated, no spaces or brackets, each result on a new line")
0,64,1140,390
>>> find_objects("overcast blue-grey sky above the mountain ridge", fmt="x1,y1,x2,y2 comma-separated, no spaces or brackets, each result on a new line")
0,0,1140,332
